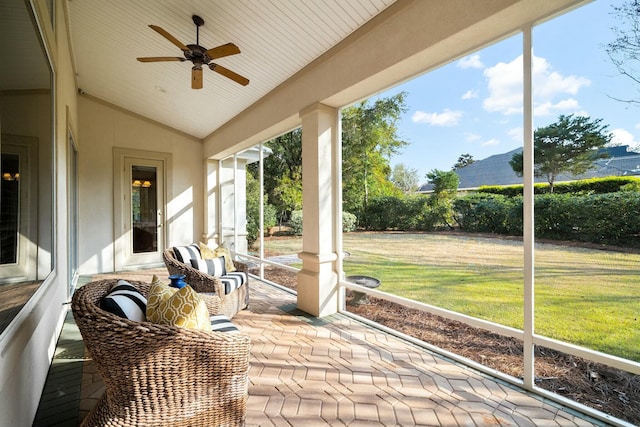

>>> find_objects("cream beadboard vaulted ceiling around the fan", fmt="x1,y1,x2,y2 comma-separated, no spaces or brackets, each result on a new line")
68,0,395,138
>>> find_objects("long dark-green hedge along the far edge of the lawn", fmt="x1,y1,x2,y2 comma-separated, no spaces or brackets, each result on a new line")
316,177,640,248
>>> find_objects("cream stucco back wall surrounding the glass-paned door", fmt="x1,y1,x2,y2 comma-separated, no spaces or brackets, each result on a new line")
79,95,204,274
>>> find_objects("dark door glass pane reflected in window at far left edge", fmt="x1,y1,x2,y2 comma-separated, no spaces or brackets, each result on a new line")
0,154,20,264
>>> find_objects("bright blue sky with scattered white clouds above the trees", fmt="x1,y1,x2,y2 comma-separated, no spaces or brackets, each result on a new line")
380,0,640,182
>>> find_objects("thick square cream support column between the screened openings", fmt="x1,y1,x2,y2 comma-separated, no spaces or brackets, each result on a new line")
298,104,339,317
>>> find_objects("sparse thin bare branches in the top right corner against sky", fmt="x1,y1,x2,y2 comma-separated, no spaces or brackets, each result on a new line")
606,0,640,105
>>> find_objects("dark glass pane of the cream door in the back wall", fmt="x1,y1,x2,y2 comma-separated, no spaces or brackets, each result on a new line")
131,165,158,254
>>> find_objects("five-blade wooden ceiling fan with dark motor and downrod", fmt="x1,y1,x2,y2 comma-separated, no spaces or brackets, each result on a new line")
138,15,249,89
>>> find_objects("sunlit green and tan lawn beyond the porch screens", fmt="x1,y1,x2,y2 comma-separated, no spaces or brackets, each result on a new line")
266,233,640,361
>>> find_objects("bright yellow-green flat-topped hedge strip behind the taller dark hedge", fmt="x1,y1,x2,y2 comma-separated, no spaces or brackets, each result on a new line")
478,176,640,197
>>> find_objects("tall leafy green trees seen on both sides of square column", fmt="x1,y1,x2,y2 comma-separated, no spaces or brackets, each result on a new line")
249,92,406,227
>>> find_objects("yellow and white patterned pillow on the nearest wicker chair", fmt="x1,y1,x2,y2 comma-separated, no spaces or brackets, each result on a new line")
146,276,211,331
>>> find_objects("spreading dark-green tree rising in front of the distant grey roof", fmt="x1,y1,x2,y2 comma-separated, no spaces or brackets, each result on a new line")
509,114,611,193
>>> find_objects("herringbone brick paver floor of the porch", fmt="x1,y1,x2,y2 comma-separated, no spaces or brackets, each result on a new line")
34,269,604,427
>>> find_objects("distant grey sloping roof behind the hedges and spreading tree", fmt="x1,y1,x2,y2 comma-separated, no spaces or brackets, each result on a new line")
418,145,640,192
